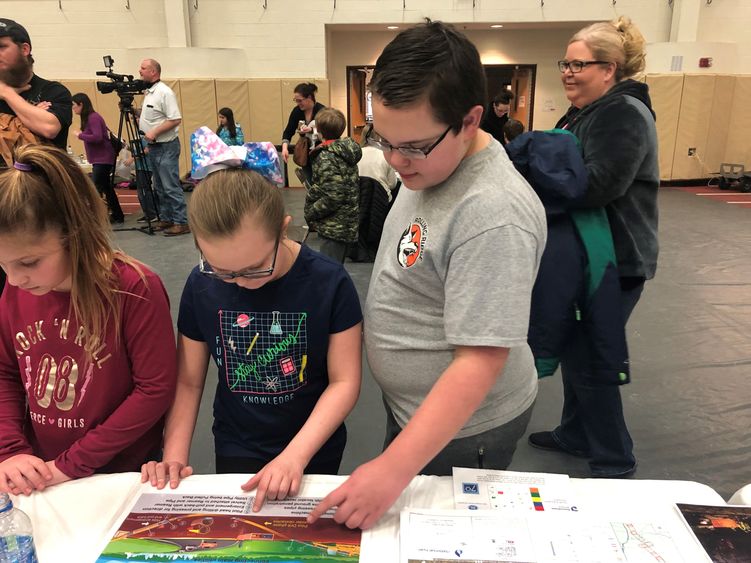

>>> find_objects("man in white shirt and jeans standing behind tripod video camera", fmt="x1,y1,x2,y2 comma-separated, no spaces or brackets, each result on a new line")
139,59,190,237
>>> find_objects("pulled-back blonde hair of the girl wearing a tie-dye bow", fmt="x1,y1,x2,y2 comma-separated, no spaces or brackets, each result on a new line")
188,169,285,239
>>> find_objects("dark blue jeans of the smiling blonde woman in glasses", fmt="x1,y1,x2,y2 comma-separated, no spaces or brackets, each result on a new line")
553,283,644,477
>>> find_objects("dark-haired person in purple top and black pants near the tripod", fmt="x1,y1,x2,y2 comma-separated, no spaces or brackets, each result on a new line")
73,92,125,223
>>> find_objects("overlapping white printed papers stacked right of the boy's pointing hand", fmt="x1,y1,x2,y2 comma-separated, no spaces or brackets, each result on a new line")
400,468,708,563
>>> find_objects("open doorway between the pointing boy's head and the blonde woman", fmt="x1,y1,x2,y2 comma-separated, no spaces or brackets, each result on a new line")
483,64,537,131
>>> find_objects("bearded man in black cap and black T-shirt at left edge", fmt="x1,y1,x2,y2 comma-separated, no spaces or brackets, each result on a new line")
0,18,73,152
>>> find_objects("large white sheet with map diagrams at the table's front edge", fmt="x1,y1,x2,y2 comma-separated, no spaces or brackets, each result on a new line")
400,509,701,563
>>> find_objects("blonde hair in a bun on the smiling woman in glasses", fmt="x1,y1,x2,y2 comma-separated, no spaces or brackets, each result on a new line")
569,16,646,82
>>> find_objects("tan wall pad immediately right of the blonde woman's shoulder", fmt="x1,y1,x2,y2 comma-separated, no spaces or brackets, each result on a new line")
647,74,683,180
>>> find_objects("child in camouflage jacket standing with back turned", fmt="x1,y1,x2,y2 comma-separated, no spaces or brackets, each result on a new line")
305,108,362,262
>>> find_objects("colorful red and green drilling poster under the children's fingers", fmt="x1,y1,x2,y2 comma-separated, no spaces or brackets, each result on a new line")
97,493,361,563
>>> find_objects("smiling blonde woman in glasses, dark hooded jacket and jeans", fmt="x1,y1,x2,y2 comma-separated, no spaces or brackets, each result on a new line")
529,17,659,478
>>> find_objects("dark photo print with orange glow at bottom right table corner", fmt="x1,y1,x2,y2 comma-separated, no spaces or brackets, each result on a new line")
676,504,751,563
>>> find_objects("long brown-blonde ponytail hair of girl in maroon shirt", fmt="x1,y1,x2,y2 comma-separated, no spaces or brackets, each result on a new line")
0,145,143,359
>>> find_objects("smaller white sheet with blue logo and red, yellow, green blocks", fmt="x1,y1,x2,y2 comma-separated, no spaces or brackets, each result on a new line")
453,467,577,512
